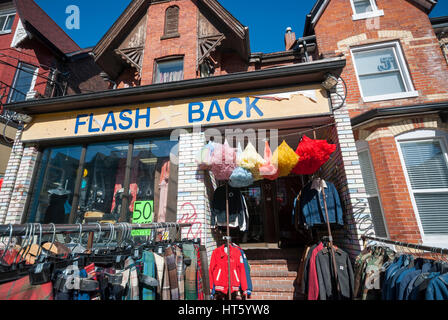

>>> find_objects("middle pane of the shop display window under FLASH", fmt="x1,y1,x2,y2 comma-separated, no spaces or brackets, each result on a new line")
78,141,129,222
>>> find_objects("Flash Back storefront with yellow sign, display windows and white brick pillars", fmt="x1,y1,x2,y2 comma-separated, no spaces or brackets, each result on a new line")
0,59,374,300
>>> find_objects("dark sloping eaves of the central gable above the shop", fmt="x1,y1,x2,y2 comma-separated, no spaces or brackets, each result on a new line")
93,0,250,77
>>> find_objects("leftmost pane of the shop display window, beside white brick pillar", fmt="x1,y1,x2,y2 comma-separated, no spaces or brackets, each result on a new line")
28,146,82,224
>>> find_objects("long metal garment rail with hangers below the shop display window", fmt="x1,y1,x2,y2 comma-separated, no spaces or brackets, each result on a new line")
0,222,193,237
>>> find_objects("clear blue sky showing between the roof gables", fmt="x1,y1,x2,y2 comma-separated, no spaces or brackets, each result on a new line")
35,0,448,53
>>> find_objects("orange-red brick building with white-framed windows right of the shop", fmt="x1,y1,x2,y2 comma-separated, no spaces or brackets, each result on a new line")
304,0,448,247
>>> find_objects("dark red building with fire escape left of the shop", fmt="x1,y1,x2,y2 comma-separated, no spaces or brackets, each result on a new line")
0,0,107,182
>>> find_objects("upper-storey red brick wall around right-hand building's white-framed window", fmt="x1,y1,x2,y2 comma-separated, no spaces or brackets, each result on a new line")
315,0,448,117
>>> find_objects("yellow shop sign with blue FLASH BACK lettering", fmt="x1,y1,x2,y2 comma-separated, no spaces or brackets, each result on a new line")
22,85,330,142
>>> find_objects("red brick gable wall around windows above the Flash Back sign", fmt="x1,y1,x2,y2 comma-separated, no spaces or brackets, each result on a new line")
141,0,198,85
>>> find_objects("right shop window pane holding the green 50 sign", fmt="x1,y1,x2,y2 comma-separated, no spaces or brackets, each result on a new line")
129,138,178,222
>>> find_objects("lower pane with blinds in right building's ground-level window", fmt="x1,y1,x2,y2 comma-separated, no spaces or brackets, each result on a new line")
415,193,448,234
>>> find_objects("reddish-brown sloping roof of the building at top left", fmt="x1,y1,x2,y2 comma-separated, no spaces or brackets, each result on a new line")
13,0,81,55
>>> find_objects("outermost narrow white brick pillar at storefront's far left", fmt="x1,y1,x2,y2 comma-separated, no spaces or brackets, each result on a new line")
0,129,23,224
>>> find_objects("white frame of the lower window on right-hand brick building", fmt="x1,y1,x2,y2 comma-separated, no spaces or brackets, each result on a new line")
395,129,448,247
